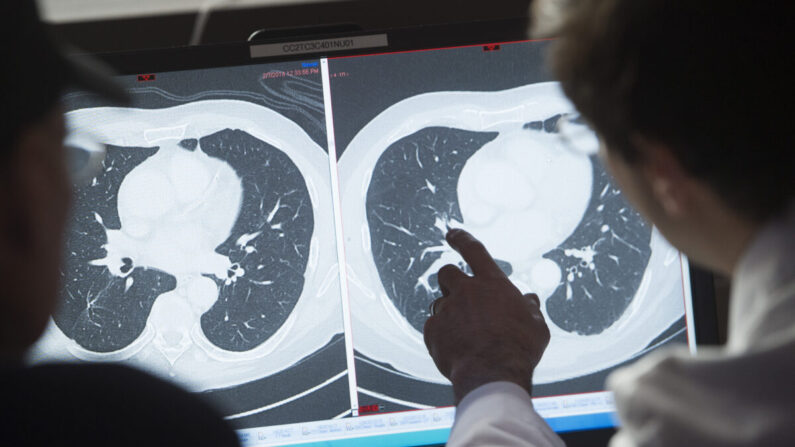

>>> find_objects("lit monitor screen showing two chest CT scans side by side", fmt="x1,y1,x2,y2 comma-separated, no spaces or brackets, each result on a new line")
30,35,695,446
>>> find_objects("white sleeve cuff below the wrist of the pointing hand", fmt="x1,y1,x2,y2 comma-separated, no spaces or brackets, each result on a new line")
447,382,564,447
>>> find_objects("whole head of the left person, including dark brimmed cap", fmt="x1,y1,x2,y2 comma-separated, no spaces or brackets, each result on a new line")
0,0,124,361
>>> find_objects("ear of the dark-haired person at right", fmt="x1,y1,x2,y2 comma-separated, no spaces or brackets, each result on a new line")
632,137,692,219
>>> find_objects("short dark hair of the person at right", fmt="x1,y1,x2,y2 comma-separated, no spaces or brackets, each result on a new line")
552,0,795,221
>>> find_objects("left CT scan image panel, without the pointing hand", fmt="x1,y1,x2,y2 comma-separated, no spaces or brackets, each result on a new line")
31,64,351,428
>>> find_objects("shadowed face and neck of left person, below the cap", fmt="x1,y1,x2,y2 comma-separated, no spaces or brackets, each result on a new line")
0,105,70,359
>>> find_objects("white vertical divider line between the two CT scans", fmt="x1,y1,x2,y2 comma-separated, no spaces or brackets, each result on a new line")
320,57,359,416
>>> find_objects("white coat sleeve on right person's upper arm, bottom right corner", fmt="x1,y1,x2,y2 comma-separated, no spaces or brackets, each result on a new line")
608,338,795,447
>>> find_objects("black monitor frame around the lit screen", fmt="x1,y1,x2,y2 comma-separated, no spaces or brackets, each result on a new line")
74,18,719,447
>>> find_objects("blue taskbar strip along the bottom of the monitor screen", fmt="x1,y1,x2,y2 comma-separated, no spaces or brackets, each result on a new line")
276,412,617,447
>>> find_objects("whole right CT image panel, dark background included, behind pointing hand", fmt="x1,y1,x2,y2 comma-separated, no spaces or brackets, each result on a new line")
329,43,685,411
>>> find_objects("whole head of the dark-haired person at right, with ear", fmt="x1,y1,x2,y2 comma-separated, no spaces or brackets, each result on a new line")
533,0,795,274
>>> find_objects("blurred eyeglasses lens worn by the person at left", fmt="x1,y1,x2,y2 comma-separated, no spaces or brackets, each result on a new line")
64,115,107,186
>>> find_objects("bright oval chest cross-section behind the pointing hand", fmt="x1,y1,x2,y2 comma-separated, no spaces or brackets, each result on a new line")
340,82,683,392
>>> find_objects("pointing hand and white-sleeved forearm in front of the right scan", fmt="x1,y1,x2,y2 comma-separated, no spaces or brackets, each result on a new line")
424,230,562,446
